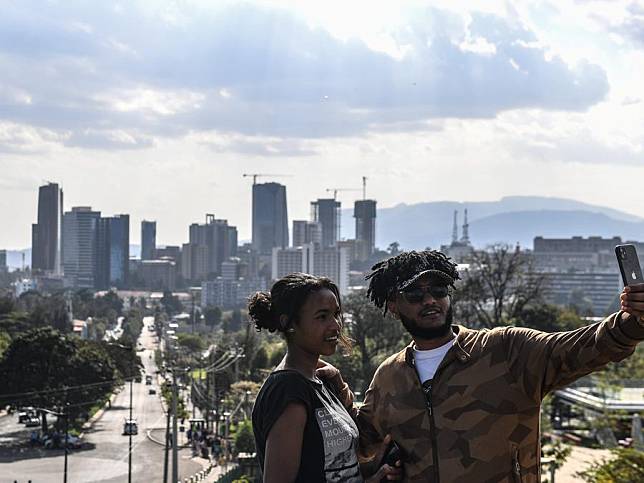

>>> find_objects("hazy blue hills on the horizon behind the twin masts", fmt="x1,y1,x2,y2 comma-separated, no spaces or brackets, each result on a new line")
342,196,644,249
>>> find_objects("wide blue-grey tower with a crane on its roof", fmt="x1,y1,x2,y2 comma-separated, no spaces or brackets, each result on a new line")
253,183,288,255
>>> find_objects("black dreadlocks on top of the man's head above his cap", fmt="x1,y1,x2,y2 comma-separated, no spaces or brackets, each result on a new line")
365,250,460,314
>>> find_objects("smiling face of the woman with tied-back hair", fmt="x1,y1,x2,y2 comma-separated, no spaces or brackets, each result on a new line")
290,288,342,356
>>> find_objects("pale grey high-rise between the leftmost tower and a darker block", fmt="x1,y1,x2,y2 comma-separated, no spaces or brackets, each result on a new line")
62,206,101,288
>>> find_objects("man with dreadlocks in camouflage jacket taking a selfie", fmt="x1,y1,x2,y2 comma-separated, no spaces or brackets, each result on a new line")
336,250,644,483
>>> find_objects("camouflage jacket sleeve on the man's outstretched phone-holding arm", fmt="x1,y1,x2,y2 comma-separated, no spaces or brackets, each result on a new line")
503,312,644,401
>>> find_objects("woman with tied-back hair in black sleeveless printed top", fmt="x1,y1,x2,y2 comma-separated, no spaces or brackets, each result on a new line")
248,273,400,483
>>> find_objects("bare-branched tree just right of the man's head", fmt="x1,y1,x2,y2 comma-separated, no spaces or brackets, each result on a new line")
455,244,546,328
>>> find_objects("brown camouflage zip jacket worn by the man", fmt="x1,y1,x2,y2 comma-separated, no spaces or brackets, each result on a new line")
354,313,644,483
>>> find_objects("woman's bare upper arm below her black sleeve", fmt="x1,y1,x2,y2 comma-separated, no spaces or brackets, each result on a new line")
264,403,307,483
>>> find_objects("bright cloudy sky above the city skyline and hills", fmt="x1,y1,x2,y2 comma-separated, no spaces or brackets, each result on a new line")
0,0,644,249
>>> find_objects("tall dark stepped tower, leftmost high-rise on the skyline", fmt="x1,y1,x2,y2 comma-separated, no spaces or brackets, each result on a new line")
31,183,63,274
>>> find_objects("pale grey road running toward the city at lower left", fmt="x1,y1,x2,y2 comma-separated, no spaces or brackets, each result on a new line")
0,317,201,483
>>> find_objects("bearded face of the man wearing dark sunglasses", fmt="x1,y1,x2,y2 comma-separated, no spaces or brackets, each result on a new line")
388,276,452,339
